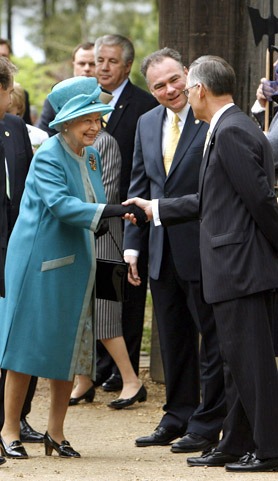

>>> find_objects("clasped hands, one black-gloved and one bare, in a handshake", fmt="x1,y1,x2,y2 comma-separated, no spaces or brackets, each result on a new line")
102,197,152,227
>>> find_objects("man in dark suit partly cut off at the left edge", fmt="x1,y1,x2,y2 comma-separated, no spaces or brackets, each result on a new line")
0,57,43,442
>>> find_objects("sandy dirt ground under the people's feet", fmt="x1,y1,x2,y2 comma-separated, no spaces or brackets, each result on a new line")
0,368,278,481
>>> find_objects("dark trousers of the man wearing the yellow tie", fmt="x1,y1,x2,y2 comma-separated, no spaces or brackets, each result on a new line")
150,233,226,440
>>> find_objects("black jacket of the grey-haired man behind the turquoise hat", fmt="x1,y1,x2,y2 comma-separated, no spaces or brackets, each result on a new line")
106,81,157,201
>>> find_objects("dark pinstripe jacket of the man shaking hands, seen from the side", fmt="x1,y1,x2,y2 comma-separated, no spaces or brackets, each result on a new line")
159,106,278,303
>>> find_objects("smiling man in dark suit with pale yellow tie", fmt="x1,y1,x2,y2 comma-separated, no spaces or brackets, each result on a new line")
124,48,225,452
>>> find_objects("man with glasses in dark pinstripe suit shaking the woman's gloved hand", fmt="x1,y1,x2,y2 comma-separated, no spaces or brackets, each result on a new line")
124,56,278,473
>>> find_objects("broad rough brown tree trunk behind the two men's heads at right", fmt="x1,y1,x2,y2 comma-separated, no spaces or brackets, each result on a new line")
159,0,275,114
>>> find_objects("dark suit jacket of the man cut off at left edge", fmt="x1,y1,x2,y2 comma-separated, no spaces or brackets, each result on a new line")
0,114,33,233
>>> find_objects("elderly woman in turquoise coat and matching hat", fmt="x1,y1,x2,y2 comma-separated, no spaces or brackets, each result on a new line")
0,77,146,459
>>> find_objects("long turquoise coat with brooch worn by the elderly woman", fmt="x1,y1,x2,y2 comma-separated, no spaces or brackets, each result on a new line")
0,134,106,380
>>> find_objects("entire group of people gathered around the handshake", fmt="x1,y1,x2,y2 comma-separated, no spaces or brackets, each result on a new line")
0,34,278,472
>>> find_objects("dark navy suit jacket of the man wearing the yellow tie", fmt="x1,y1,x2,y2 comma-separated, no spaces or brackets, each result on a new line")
124,106,208,280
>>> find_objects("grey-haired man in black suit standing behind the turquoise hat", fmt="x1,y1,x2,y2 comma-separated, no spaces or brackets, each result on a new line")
95,35,157,391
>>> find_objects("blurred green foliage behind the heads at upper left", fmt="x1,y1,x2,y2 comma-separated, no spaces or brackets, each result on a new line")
4,0,158,112
